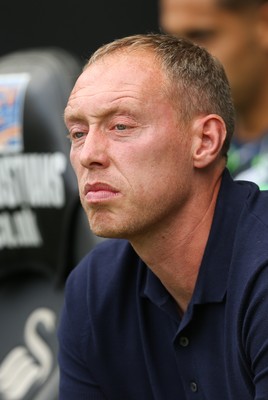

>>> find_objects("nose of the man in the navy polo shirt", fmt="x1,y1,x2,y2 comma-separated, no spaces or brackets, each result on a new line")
80,130,109,168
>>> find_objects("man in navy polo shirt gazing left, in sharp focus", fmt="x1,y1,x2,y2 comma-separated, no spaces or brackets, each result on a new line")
59,34,268,400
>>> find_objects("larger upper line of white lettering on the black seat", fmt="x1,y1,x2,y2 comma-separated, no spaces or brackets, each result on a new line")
0,153,67,208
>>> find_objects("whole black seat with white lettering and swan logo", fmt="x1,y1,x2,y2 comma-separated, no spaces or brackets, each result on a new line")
0,48,98,400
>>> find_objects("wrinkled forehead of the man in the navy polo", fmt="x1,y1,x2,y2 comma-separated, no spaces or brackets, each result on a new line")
65,51,169,118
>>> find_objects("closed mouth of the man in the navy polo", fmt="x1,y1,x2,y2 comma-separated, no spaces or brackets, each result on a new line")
84,182,119,204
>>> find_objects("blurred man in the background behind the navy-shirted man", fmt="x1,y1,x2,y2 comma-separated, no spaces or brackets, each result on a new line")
159,0,268,188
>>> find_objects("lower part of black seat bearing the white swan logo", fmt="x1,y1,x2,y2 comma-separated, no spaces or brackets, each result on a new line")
0,273,63,400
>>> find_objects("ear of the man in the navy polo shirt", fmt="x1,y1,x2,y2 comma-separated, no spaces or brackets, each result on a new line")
193,114,226,168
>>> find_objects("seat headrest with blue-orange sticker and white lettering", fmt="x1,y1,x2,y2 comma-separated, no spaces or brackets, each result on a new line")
0,48,81,276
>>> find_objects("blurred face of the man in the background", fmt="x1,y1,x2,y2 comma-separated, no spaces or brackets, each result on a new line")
159,0,267,111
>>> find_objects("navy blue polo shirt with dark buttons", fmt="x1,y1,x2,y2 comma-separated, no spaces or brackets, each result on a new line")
58,171,268,400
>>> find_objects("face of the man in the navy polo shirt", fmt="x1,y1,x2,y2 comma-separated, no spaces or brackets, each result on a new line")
65,51,193,239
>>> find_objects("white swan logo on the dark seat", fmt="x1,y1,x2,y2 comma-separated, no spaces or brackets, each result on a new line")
0,308,56,400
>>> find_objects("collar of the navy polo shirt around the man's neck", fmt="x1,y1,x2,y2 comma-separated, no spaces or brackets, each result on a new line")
143,169,252,307
